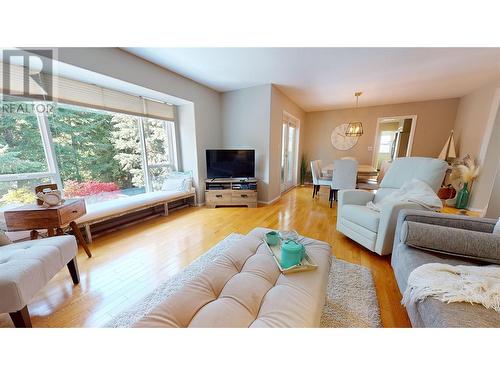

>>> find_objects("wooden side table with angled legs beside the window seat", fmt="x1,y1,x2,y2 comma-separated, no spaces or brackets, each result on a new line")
4,198,92,258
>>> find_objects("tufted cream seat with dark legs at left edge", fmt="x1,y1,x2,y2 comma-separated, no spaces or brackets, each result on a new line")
0,236,78,312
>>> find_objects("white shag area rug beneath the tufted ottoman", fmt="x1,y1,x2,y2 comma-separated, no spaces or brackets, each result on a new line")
105,233,382,328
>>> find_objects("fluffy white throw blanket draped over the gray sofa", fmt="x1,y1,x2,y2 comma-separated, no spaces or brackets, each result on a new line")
402,263,500,312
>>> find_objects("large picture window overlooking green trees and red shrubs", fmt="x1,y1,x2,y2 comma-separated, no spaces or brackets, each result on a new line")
0,97,177,210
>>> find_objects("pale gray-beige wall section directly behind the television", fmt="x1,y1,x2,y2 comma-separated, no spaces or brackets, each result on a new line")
221,85,271,202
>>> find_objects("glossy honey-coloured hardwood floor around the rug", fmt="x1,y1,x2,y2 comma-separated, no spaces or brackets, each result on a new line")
0,187,410,327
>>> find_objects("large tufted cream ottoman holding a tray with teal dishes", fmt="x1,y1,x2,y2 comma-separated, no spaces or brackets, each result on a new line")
135,228,331,328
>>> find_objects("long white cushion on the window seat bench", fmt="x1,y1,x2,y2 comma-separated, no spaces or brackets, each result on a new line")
76,189,194,224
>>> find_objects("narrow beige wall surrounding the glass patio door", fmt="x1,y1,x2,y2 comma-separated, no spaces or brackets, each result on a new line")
269,85,306,201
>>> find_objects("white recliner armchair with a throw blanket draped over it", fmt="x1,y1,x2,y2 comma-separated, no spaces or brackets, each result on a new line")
337,157,448,255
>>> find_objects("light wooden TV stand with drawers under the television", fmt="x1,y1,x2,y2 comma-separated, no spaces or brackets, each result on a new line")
205,178,257,208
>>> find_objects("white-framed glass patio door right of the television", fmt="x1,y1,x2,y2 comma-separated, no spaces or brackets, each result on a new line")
281,115,299,192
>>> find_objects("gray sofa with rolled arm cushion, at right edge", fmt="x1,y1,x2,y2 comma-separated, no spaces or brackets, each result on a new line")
391,210,500,327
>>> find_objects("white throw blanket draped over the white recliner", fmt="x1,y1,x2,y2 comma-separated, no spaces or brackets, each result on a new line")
366,178,443,212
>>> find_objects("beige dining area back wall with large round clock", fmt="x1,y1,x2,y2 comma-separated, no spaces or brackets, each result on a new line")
304,99,458,164
